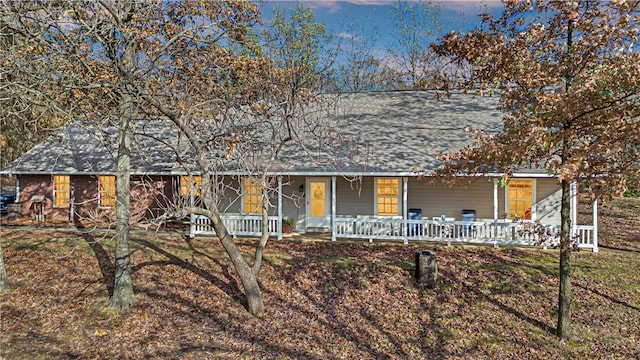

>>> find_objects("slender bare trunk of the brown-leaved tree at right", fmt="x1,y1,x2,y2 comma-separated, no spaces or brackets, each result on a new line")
556,180,572,340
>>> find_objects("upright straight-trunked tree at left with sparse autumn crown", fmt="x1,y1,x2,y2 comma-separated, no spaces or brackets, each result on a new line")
2,1,264,309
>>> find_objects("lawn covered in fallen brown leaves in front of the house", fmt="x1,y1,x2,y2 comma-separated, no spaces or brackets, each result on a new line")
0,199,640,359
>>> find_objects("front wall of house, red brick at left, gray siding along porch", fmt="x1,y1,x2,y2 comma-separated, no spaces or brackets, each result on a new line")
19,175,561,226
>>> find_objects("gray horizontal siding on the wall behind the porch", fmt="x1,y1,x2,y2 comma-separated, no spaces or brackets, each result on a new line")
221,176,561,231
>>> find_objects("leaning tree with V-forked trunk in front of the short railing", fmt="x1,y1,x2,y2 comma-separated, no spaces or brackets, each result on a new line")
142,4,336,316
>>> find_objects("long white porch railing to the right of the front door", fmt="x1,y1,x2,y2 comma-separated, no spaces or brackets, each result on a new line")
333,217,597,251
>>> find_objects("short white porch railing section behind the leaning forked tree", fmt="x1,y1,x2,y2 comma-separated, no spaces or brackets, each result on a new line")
189,214,282,239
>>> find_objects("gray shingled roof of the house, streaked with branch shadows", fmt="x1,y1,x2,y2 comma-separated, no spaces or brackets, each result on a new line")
1,91,516,175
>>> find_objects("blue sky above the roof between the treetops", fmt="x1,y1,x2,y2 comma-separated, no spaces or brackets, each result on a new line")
255,0,503,50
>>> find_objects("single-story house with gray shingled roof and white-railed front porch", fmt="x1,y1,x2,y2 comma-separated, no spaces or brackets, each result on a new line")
0,91,597,251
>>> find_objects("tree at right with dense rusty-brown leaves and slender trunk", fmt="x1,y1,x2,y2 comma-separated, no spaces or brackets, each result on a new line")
433,0,640,339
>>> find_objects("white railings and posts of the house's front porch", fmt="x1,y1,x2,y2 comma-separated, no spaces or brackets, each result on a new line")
190,176,598,252
